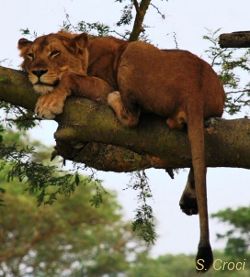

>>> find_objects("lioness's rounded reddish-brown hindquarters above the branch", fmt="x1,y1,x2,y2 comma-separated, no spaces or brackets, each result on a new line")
118,42,224,117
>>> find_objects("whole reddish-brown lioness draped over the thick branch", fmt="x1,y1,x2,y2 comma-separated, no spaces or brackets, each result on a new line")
18,32,225,270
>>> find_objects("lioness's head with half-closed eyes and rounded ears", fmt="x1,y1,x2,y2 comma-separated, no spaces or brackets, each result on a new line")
18,32,88,94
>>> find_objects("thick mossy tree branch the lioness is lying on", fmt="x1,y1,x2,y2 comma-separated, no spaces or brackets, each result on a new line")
0,67,250,172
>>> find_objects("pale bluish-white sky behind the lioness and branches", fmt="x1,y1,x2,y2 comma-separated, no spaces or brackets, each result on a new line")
0,0,250,256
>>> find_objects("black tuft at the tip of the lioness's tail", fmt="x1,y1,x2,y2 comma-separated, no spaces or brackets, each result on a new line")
196,245,213,273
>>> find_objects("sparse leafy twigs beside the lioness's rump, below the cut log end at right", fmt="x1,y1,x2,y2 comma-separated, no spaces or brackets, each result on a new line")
204,29,250,115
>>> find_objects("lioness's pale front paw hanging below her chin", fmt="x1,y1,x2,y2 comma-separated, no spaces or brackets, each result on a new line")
35,92,66,119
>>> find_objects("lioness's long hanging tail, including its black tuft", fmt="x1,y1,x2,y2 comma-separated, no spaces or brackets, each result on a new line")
187,105,213,271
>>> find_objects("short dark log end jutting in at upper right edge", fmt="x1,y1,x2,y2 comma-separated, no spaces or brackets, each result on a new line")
219,31,250,48
